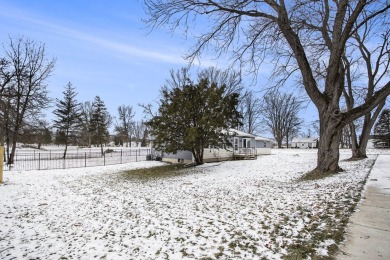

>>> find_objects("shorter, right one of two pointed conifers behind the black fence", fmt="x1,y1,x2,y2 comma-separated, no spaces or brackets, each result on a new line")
89,96,111,155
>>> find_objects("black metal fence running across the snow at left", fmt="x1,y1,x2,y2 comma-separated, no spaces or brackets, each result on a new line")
4,148,151,171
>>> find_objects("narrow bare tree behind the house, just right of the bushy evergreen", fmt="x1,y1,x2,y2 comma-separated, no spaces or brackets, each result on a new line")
240,91,261,134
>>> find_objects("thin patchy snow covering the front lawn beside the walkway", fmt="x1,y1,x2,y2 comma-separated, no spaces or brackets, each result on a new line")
0,150,376,259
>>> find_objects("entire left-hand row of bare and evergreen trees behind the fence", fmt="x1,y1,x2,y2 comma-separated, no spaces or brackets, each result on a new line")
0,37,146,164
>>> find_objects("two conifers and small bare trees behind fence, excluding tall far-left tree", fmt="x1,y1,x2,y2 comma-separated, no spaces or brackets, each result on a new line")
49,83,151,157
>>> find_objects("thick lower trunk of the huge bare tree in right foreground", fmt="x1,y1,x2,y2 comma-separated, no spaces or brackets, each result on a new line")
314,109,344,174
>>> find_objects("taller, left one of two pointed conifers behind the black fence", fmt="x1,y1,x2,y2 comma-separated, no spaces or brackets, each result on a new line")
53,82,81,158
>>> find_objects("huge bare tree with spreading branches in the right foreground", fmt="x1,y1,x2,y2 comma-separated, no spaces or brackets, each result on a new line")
145,0,390,174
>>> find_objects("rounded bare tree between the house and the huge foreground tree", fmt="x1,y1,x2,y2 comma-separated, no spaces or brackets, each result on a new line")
262,91,302,148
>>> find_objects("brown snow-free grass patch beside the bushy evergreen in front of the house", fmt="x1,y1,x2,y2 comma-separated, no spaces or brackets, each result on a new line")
123,164,187,181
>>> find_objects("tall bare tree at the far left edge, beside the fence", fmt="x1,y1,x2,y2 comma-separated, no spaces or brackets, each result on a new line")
3,37,55,164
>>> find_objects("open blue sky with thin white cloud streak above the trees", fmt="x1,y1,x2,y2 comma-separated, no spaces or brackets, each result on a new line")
0,0,315,134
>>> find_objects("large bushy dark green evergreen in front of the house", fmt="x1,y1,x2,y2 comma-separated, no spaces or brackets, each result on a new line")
147,78,240,164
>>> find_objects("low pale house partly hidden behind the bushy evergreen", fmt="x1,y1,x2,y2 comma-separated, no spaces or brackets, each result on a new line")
160,128,271,163
